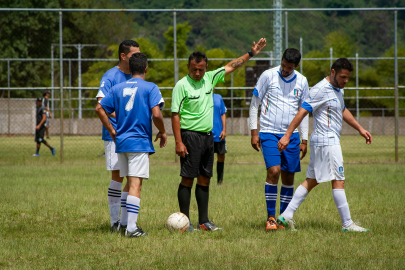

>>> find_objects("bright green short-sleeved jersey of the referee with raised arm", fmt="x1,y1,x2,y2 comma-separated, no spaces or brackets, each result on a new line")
171,67,225,132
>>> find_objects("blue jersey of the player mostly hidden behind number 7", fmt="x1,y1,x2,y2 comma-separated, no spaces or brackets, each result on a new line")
96,67,132,141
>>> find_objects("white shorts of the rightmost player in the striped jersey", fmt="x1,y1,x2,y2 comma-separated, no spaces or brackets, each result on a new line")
307,145,345,183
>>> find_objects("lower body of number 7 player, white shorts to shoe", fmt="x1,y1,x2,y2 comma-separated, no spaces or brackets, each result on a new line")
124,153,149,237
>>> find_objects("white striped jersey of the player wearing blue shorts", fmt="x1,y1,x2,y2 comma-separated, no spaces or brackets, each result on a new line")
253,66,309,140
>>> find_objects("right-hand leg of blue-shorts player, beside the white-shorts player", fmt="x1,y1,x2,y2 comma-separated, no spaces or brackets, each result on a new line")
280,132,301,214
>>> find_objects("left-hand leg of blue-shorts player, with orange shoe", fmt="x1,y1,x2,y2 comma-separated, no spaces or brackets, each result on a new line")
259,132,281,231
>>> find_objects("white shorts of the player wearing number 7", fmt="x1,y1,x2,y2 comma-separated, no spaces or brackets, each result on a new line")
118,153,149,179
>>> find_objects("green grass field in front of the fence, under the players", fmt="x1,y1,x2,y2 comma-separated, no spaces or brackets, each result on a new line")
0,161,405,269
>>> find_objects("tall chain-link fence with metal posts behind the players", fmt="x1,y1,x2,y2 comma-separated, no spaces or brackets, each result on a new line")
0,9,405,164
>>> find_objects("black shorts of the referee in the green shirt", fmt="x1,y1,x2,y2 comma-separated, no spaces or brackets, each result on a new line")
180,129,214,178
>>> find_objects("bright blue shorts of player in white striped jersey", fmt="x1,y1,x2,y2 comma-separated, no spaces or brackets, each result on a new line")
259,132,301,173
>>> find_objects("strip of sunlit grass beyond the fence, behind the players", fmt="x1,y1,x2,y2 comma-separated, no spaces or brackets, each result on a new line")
0,135,405,165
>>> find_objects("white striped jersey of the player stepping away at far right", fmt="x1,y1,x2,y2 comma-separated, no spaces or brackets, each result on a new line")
302,79,346,146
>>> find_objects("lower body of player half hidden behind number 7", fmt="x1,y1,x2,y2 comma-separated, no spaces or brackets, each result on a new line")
104,141,125,232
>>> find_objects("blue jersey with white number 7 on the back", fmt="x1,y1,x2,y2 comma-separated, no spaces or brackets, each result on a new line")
100,78,164,154
